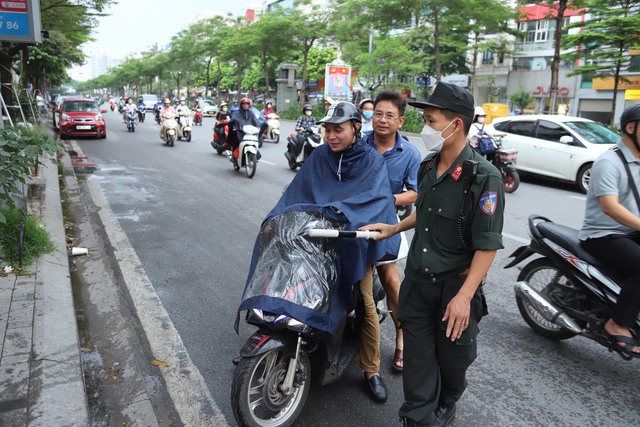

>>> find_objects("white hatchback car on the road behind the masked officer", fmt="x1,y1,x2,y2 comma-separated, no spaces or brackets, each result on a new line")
491,115,620,193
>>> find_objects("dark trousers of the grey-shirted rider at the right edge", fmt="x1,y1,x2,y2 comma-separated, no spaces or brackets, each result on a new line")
582,233,640,328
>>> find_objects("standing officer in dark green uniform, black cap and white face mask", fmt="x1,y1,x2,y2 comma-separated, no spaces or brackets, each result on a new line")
362,83,504,426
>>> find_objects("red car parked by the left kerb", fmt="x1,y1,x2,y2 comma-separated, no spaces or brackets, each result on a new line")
56,98,107,139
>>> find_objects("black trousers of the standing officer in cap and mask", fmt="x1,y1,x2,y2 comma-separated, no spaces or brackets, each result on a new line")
398,276,486,423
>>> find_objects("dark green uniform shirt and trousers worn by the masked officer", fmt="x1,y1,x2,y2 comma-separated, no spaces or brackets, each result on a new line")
398,145,504,423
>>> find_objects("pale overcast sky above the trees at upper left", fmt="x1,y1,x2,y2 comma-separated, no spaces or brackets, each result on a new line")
69,0,262,80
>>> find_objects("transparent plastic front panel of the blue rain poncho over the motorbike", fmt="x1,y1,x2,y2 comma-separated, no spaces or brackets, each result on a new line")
243,211,345,314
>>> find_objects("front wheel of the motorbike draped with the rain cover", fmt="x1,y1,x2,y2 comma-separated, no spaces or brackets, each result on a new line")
231,349,311,427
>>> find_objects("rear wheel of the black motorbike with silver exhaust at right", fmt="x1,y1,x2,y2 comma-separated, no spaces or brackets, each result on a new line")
516,258,585,340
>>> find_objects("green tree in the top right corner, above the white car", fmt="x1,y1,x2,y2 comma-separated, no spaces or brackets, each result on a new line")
563,0,640,126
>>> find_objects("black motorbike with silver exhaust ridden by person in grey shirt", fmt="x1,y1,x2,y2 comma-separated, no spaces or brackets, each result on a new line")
505,215,640,360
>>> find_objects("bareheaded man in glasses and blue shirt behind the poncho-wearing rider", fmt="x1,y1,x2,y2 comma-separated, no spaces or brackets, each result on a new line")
361,91,420,372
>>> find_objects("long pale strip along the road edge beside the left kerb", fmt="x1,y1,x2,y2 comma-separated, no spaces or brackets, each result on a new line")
88,179,229,427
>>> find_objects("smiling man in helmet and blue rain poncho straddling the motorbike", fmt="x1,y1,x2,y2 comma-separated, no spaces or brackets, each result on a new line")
270,102,400,403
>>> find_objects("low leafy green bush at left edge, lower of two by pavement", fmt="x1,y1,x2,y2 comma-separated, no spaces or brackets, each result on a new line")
0,209,55,265
